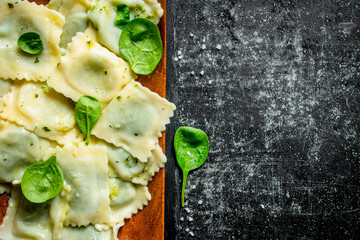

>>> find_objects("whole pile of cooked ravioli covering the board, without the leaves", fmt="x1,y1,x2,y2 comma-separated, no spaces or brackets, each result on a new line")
0,0,175,240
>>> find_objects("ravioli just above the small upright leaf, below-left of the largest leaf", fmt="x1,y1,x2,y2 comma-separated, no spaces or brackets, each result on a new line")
48,31,136,103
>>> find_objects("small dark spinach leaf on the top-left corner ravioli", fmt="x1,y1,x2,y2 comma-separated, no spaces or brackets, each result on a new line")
18,32,44,55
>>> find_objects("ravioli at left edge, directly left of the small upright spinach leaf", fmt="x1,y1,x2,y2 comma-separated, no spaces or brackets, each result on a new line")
0,82,80,144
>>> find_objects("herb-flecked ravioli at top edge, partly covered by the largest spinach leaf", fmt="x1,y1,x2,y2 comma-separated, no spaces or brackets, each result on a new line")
88,0,163,55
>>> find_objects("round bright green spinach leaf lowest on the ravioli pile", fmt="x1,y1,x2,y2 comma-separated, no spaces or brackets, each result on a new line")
21,154,64,203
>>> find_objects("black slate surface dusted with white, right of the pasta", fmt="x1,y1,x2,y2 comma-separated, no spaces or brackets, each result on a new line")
166,0,360,240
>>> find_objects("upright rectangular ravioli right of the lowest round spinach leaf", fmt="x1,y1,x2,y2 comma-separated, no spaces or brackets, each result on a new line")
47,145,110,226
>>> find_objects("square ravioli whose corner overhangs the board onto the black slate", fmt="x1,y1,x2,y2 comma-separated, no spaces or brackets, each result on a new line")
92,81,175,162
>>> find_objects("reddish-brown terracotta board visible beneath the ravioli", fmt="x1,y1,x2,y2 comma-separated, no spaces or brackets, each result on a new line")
0,0,166,240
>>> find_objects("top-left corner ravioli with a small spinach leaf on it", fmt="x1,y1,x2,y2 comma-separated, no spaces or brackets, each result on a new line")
0,0,65,82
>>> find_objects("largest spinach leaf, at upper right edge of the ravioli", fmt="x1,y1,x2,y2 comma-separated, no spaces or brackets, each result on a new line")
119,18,163,75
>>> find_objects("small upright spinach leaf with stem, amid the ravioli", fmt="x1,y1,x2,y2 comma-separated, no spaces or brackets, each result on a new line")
75,95,101,144
